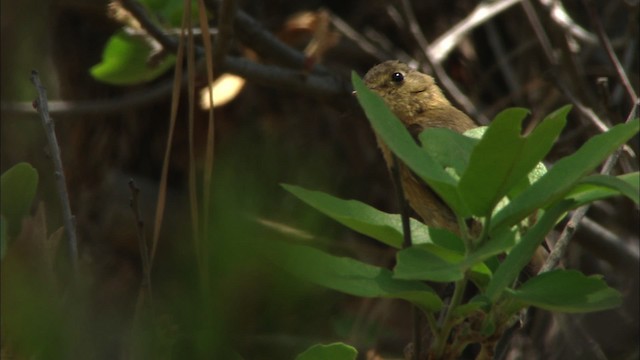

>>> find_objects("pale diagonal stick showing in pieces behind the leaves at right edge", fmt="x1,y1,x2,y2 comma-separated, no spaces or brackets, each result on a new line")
538,102,639,274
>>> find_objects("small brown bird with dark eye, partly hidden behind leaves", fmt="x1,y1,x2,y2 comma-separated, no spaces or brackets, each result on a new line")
364,60,477,234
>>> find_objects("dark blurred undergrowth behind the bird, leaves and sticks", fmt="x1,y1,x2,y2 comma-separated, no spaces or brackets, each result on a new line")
0,0,639,359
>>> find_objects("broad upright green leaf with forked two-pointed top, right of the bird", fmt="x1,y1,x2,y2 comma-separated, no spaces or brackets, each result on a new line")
459,107,570,216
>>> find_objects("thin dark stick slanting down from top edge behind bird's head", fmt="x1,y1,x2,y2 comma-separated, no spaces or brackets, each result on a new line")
401,0,489,124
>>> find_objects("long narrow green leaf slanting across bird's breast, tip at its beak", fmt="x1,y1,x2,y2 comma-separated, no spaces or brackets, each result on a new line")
351,72,469,217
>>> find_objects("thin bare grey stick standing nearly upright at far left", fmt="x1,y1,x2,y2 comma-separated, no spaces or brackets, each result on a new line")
31,70,78,278
